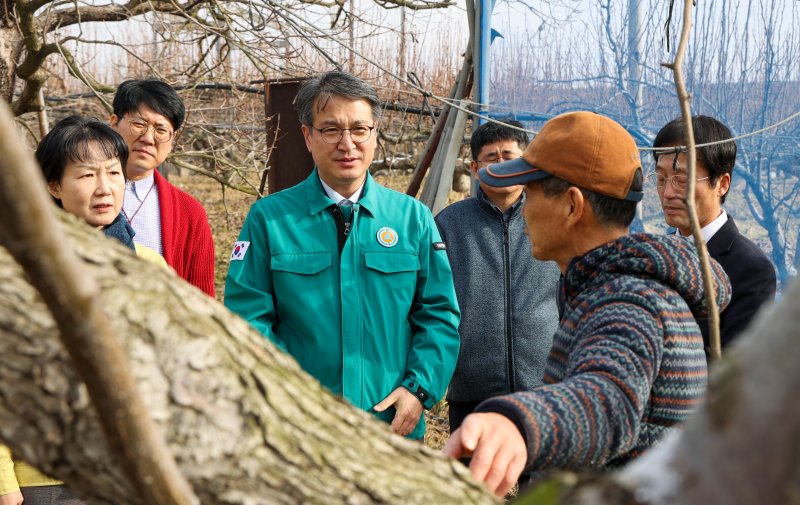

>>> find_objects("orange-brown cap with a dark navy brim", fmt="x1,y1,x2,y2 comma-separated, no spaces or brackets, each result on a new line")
478,111,642,202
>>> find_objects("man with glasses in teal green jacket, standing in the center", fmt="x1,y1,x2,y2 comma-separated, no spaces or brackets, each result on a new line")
225,72,460,439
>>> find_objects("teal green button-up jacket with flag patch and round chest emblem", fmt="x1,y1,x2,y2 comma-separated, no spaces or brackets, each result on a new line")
225,170,460,438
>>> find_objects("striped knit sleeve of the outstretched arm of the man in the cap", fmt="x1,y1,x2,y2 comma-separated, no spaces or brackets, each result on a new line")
477,298,663,470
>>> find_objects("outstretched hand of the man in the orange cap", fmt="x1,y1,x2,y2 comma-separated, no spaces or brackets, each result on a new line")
443,412,528,497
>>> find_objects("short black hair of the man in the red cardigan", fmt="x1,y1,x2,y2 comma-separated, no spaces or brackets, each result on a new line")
113,79,186,131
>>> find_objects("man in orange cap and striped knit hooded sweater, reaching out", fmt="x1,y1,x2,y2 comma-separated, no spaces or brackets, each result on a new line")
444,112,730,496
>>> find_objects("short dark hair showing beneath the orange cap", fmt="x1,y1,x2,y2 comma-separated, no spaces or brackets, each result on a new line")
528,168,644,228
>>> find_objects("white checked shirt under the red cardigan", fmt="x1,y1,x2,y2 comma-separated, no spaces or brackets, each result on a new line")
122,174,164,256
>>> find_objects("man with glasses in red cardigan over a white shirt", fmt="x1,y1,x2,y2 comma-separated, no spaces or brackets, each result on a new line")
111,79,214,297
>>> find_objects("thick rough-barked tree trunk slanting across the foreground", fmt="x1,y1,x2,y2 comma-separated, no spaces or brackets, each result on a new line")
0,211,493,504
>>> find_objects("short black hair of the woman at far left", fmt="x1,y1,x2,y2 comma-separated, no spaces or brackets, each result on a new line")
36,116,128,205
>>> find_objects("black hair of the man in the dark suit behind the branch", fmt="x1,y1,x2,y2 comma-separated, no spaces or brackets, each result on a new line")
653,116,736,203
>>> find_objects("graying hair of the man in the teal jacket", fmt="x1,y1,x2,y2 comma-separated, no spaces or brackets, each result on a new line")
294,70,381,126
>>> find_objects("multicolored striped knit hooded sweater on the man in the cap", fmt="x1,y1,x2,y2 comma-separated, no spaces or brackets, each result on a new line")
478,234,731,470
